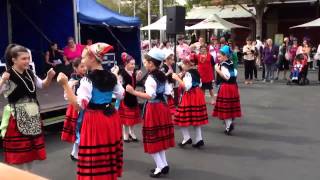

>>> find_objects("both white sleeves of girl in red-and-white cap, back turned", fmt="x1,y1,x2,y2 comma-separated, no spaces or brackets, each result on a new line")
77,77,124,108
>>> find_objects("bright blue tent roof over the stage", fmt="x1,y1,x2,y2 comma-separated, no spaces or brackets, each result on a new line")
77,0,140,27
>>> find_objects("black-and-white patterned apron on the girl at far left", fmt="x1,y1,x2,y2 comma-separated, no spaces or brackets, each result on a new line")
13,102,42,136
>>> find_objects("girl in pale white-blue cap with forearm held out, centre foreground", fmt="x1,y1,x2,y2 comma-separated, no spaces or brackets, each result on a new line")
126,48,175,178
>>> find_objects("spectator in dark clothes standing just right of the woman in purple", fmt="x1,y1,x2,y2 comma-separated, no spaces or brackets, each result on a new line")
276,37,291,80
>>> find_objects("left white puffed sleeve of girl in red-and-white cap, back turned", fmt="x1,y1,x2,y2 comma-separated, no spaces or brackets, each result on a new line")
77,77,92,109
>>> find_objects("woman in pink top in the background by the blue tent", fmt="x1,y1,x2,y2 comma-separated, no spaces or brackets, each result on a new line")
63,37,85,66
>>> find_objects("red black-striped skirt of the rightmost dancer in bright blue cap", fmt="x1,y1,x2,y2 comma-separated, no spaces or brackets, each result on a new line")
212,83,241,120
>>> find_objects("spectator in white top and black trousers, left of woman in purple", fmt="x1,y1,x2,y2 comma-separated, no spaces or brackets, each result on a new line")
242,37,255,84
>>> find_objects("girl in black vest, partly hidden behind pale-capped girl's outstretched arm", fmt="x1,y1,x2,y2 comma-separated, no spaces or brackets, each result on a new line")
119,52,142,142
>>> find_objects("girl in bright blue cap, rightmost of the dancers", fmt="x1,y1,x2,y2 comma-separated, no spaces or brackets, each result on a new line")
212,45,241,135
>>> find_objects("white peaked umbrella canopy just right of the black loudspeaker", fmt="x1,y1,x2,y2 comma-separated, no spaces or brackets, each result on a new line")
187,14,247,30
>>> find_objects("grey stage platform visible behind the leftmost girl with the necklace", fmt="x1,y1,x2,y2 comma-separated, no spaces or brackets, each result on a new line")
0,82,67,126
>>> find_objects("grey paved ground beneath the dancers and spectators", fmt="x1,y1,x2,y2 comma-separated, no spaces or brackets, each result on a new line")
0,68,320,180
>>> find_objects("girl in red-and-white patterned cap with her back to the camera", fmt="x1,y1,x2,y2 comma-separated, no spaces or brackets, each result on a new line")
57,43,125,180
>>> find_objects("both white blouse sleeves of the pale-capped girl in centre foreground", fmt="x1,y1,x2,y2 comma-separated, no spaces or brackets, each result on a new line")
144,75,173,99
